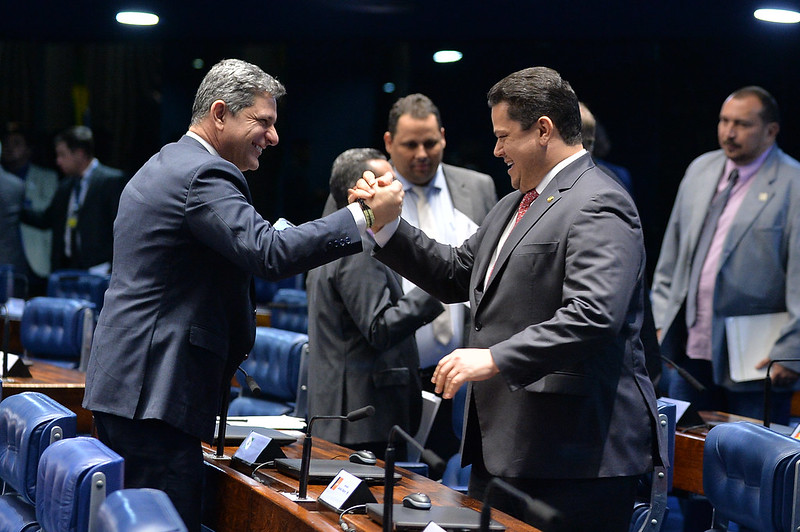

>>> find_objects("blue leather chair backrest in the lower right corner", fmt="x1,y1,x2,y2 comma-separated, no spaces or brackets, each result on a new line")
703,421,800,532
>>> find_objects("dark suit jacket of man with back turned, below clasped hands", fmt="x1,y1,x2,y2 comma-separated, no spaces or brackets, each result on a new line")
307,241,444,445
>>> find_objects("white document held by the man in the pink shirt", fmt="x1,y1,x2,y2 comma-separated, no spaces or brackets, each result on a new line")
725,312,789,382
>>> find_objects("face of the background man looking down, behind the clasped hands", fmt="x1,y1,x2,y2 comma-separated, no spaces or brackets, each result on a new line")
383,114,445,185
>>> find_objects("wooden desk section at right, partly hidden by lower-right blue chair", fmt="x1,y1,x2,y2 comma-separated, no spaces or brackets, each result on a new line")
672,412,761,495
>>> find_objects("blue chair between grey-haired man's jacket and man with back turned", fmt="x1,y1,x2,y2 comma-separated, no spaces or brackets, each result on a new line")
228,327,308,416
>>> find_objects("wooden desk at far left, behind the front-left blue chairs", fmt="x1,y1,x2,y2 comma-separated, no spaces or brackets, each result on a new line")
3,361,92,434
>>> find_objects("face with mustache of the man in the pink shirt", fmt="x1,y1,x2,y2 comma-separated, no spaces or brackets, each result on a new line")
717,94,779,165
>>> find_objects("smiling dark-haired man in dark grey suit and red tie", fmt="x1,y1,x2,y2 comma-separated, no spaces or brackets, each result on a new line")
359,67,665,531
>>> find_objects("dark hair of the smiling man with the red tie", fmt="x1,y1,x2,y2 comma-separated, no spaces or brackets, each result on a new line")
487,67,581,146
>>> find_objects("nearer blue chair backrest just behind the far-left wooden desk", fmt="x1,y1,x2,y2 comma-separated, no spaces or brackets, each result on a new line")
20,297,95,367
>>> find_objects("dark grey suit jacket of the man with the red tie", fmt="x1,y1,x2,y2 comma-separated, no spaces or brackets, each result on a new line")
376,155,665,478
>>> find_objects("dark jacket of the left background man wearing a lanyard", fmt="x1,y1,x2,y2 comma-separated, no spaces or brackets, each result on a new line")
23,164,125,271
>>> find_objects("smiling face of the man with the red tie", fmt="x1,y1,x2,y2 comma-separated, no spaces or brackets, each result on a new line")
492,102,547,192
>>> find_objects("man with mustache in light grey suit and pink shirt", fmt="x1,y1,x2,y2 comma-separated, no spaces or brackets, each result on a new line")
652,86,800,423
